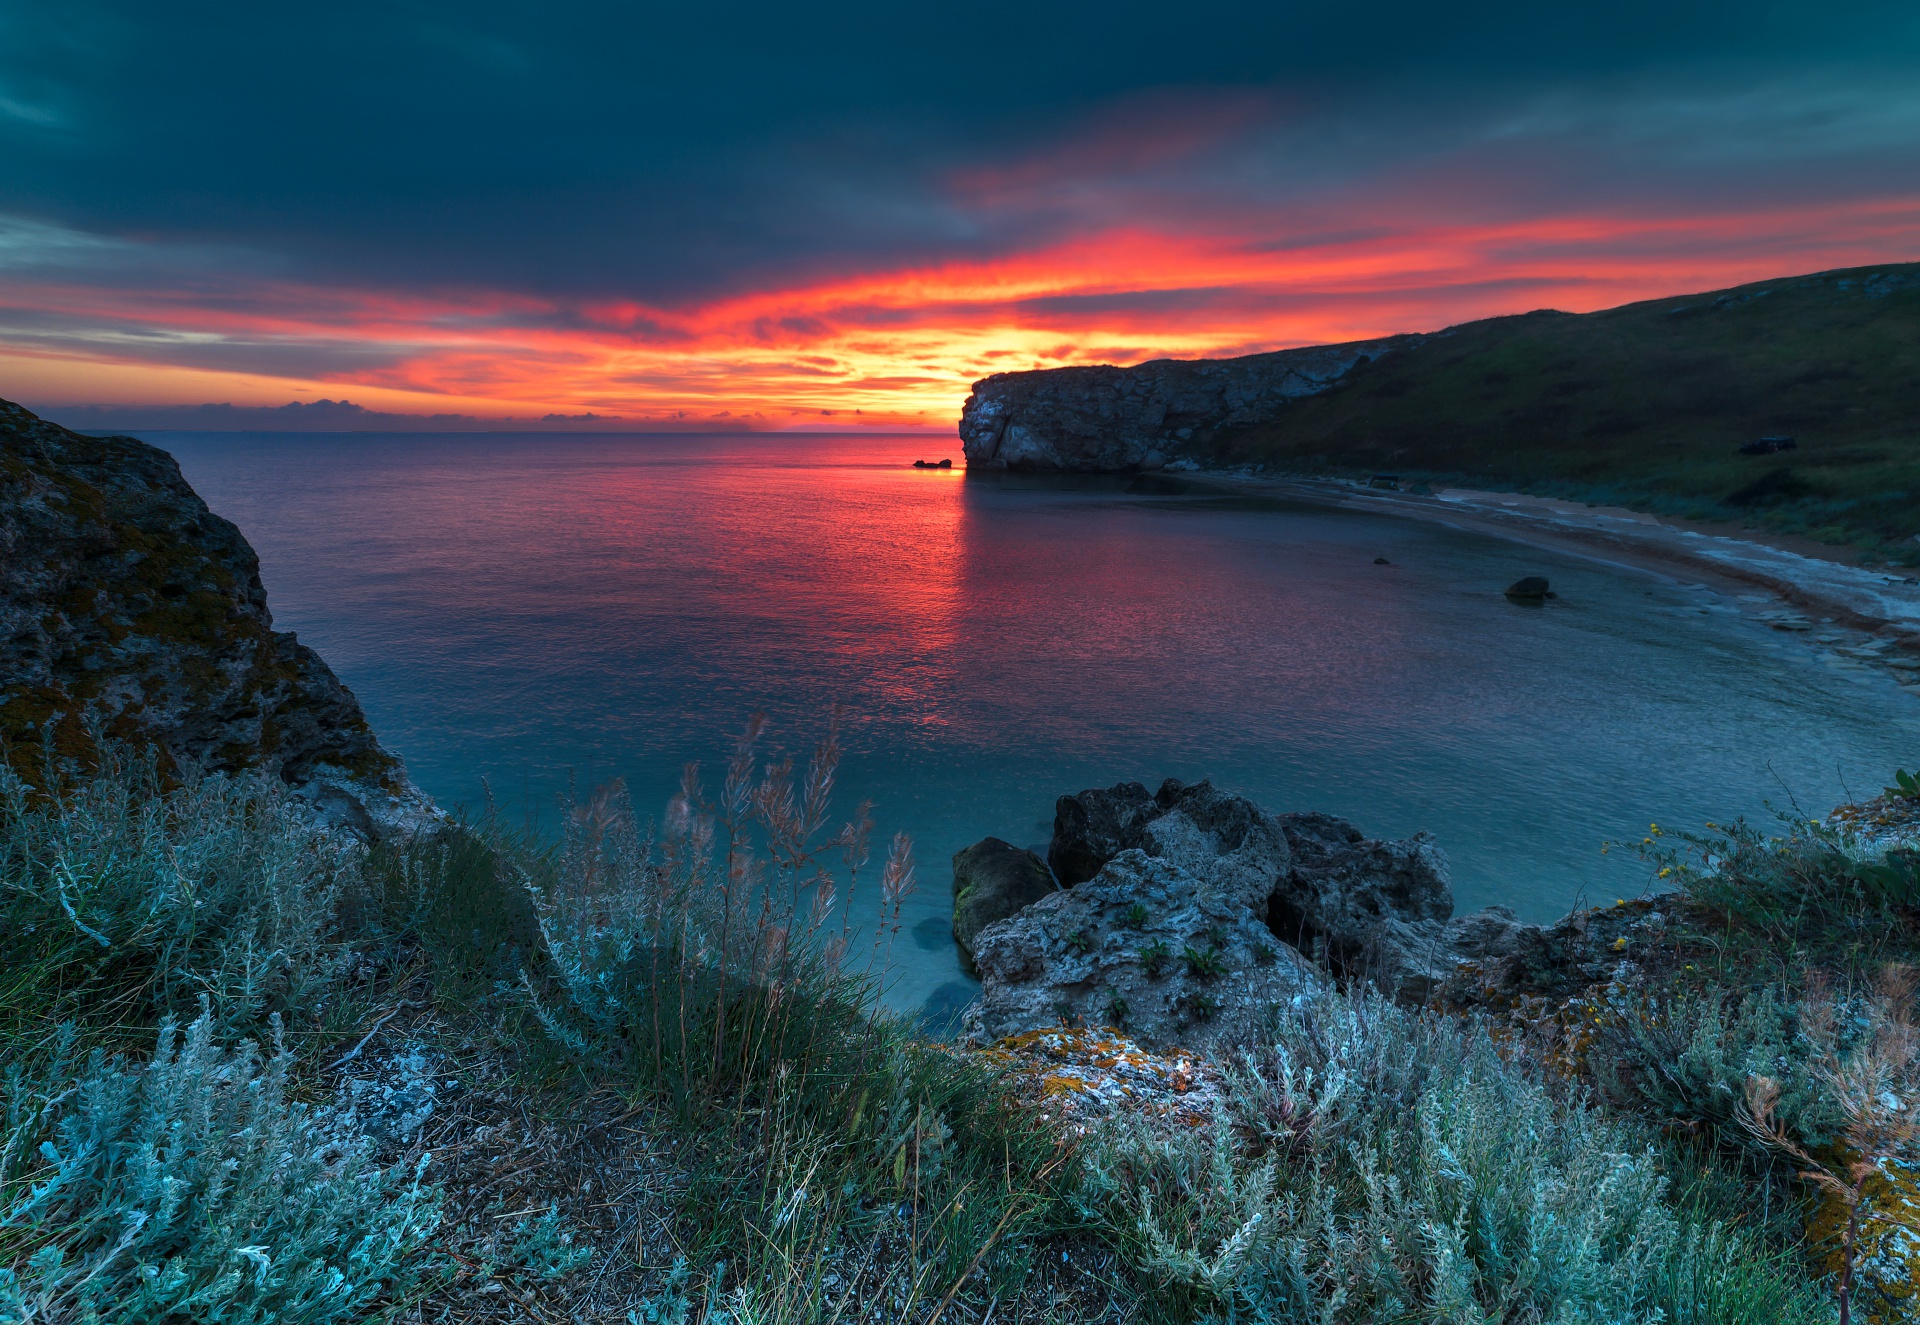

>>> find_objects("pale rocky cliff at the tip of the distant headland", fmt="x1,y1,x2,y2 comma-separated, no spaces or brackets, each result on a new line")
960,336,1421,474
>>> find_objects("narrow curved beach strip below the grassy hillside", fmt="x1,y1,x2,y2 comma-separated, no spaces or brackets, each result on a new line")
1187,470,1920,699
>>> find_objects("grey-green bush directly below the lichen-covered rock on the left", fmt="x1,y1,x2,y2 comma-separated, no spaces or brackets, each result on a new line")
0,749,359,1037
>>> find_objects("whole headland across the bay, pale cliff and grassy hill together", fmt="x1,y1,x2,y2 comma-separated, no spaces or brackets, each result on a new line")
960,263,1920,566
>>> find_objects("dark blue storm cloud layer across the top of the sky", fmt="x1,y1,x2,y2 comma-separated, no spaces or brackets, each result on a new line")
0,0,1920,303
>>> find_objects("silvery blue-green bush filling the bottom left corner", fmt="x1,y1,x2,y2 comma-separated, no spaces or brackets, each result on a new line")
0,1010,438,1325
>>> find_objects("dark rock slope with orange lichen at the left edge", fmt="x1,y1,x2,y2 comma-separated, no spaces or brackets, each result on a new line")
0,401,440,835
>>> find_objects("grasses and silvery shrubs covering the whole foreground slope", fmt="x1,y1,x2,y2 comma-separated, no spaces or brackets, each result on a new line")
0,726,1920,1325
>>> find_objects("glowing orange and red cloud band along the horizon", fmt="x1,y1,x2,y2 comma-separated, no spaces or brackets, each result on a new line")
11,198,1920,428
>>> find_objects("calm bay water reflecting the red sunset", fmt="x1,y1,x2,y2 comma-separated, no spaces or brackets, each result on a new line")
148,432,1920,1012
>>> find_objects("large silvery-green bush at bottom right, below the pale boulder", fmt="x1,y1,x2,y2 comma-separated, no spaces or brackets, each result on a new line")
1081,995,1820,1325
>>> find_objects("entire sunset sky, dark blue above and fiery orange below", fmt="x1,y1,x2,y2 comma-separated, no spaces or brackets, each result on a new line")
0,0,1920,430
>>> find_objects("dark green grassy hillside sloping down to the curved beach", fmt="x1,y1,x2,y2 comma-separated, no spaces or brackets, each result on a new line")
1213,263,1920,565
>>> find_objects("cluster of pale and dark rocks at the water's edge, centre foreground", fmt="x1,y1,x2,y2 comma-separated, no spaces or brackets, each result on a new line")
968,780,1542,1047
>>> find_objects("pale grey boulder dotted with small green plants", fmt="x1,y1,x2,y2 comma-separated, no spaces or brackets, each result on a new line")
966,851,1321,1052
